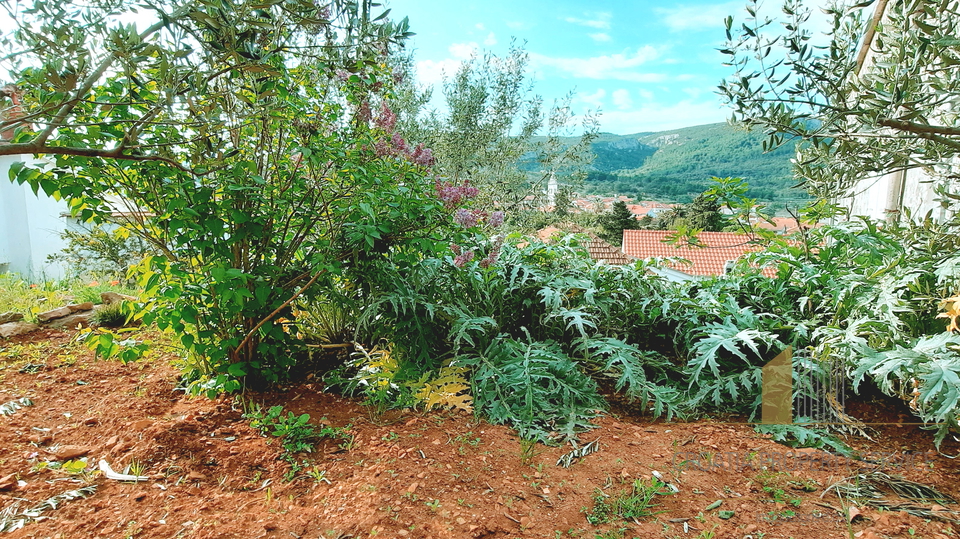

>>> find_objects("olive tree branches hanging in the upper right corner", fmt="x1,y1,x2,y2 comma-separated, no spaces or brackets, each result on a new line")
720,0,960,197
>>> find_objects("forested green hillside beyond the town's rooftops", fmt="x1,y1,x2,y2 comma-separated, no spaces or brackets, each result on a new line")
583,123,806,202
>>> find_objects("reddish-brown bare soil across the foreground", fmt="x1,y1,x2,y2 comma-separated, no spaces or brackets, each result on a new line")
0,331,960,539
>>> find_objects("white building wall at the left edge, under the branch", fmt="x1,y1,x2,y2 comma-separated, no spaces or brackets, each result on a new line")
0,155,68,280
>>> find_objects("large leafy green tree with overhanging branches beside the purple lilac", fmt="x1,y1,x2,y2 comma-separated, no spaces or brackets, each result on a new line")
0,0,454,392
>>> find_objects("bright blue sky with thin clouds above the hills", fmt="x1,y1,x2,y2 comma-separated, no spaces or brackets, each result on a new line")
386,0,745,134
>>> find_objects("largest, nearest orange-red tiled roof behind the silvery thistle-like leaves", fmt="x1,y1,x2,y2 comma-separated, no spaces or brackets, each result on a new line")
623,230,775,277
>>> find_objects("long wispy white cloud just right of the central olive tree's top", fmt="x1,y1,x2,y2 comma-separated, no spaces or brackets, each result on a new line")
530,45,667,82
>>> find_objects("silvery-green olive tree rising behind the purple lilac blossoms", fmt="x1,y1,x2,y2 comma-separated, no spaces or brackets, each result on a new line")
401,44,597,211
